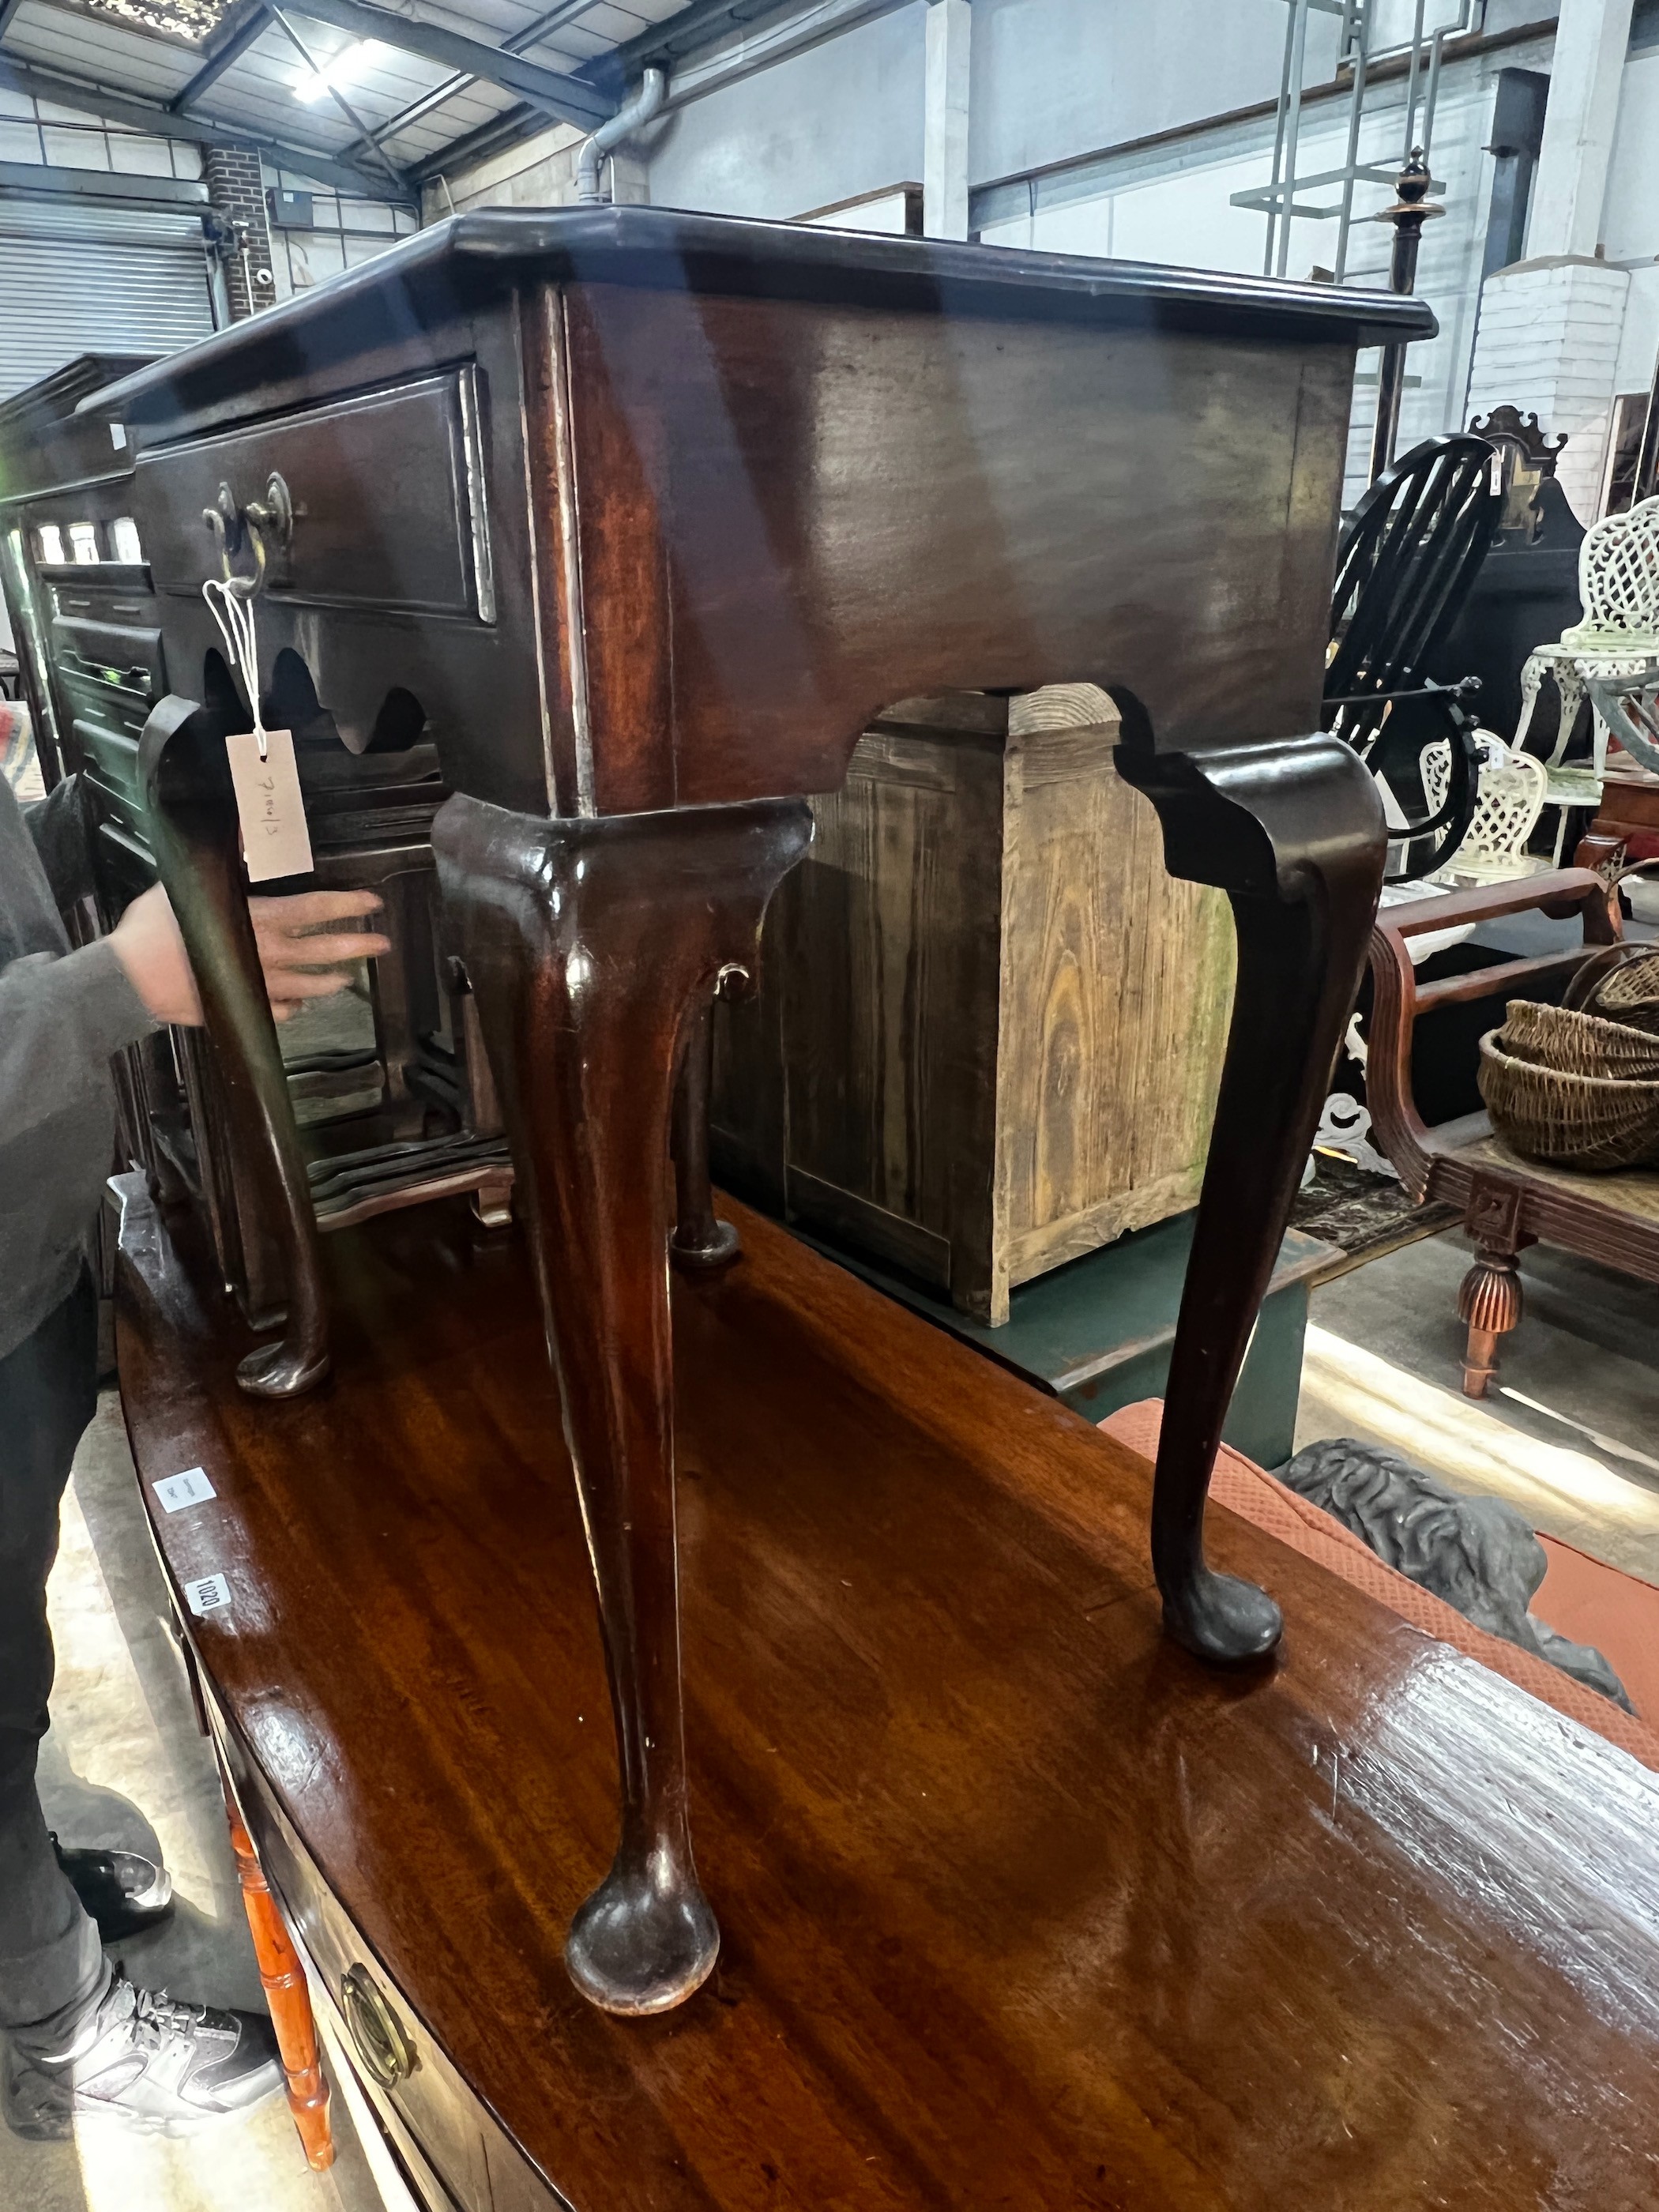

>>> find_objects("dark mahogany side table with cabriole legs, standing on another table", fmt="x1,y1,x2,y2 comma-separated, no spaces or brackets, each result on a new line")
25,208,1433,2013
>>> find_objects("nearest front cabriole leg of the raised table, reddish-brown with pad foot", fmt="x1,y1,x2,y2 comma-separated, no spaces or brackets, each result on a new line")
434,796,812,2013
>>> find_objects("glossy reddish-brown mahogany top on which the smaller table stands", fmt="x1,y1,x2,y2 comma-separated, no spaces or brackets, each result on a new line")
119,1179,1659,2212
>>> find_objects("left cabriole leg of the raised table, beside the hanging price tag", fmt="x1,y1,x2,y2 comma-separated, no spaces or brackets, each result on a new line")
139,697,327,1398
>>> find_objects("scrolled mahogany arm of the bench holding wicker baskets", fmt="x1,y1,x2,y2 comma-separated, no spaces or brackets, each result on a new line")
1365,867,1623,1199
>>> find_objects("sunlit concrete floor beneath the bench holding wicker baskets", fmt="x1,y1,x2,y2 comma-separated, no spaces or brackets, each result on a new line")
1296,1230,1659,1582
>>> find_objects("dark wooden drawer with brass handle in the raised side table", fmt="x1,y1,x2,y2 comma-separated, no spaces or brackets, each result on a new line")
135,367,495,622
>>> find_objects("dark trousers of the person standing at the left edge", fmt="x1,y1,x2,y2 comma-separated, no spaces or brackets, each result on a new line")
0,1274,106,2051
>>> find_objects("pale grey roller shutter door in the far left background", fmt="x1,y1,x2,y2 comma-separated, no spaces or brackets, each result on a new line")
0,199,213,398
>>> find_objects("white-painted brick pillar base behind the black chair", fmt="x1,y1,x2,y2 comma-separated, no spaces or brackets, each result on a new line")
1469,254,1631,525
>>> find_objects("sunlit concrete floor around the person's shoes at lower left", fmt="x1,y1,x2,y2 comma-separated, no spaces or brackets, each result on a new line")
0,1394,381,2212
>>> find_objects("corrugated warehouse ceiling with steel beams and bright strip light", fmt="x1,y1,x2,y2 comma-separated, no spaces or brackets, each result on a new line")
0,0,752,201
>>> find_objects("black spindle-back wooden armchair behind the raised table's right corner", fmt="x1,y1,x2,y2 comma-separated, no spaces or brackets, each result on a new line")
1322,431,1504,876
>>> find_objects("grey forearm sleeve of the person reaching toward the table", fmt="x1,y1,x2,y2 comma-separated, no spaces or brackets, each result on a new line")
0,938,157,1139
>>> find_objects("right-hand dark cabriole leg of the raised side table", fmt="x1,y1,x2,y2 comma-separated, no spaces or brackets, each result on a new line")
1117,736,1387,1664
